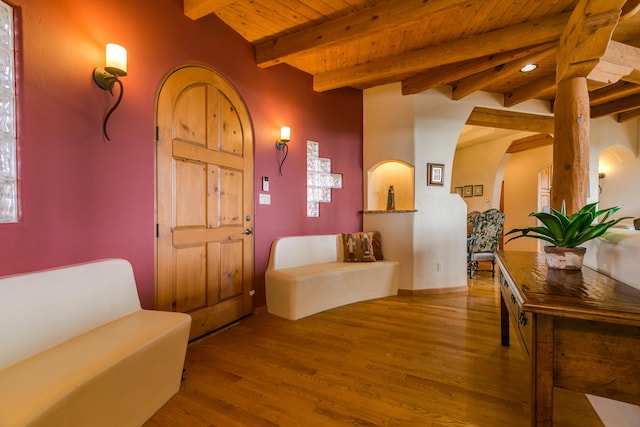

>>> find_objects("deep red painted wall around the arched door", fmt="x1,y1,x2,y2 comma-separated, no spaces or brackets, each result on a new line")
0,0,362,307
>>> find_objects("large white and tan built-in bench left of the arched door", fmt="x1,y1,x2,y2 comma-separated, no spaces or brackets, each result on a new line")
0,259,191,427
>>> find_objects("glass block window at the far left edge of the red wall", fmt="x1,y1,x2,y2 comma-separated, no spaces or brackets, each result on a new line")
0,1,18,223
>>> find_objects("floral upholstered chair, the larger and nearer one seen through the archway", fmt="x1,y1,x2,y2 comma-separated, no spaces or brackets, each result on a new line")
467,209,504,277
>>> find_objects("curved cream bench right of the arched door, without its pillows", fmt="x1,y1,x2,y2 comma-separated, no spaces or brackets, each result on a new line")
265,234,399,320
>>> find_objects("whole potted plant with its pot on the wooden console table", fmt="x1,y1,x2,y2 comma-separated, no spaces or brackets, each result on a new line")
505,200,631,270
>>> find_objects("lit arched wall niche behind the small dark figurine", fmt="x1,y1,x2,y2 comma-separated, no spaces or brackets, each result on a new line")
366,160,415,211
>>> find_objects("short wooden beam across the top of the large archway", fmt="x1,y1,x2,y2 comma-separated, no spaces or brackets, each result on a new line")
467,107,554,133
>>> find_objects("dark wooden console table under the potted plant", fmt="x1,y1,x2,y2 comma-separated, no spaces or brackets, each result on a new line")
496,251,640,427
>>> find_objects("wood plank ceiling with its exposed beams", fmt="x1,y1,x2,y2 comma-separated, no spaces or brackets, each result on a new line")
184,0,640,122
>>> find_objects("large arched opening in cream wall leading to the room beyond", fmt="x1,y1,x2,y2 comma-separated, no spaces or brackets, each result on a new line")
451,107,554,251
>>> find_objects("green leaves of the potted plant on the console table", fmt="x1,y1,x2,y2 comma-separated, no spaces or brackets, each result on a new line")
505,201,631,248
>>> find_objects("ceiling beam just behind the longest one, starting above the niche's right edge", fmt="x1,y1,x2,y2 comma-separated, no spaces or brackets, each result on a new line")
402,42,557,95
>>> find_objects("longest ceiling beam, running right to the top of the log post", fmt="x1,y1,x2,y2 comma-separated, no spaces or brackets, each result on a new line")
313,12,570,91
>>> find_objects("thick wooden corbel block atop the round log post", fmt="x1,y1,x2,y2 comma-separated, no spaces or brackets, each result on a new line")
556,0,625,82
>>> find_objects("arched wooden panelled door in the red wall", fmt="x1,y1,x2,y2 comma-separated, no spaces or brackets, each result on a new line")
156,66,253,338
